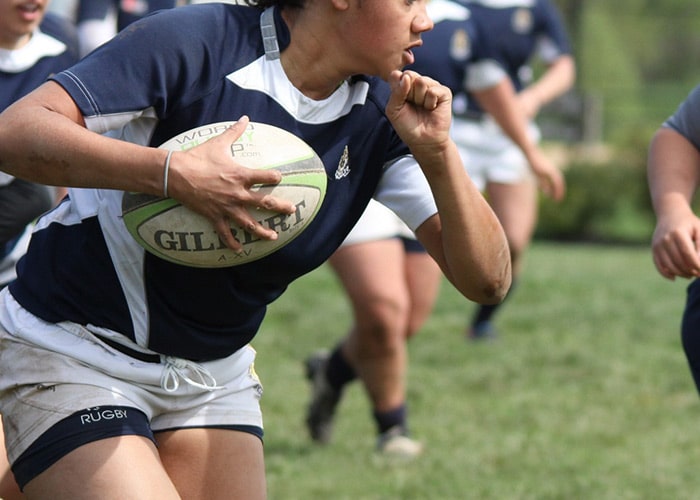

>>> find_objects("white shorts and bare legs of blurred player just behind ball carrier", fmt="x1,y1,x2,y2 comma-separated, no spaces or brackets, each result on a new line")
306,197,442,458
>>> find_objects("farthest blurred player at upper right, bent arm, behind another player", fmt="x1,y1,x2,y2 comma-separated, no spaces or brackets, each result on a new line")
460,0,576,339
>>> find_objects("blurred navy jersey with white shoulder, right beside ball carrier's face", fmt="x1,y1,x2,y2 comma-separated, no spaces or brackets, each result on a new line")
410,0,505,114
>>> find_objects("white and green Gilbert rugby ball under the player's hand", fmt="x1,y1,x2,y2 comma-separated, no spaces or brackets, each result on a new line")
122,122,327,268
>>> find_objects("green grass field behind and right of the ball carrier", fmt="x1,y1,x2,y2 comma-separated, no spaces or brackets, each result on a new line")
250,242,700,500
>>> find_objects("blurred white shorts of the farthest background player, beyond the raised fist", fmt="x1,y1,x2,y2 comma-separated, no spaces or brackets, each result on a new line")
450,116,540,191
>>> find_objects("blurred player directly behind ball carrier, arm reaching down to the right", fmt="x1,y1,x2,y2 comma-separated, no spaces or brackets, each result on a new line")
306,0,562,459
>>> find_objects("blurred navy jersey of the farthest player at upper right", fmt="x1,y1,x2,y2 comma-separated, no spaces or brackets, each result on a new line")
460,0,571,111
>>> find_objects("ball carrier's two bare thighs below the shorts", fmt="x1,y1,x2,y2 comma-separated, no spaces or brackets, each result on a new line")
25,429,266,500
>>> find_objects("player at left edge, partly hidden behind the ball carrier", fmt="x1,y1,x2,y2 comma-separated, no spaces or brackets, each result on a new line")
0,0,78,500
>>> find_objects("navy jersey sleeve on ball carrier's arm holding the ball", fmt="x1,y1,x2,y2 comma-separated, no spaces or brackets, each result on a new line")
53,4,235,133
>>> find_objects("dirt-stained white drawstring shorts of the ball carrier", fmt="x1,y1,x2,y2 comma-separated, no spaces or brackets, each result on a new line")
0,289,263,482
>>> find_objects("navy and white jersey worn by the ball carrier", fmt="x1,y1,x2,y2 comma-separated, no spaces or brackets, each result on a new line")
10,3,436,360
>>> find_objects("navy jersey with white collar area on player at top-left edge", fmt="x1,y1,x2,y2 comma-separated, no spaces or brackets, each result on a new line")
0,13,78,111
